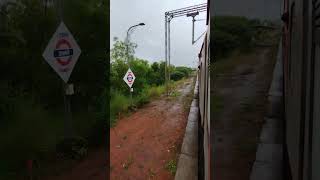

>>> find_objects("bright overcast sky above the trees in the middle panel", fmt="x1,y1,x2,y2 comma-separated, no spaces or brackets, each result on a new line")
110,0,207,67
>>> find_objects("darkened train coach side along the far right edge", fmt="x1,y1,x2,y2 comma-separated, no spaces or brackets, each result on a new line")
283,0,320,180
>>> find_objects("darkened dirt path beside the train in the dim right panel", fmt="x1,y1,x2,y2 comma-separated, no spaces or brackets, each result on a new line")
213,48,275,180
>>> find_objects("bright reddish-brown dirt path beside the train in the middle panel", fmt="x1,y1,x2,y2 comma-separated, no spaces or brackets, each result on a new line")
110,79,193,180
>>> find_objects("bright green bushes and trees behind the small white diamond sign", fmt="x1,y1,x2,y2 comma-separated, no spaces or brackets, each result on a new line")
109,39,192,126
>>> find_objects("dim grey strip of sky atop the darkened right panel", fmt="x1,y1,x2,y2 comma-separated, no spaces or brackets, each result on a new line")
210,0,282,20
